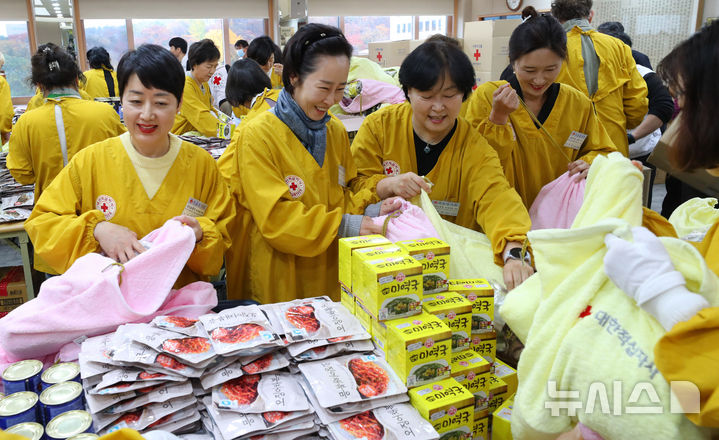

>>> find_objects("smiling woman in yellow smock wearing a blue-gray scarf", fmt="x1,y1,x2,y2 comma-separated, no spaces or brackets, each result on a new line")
227,23,401,303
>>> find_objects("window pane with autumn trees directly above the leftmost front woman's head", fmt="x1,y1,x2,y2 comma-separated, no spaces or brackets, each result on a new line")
132,18,225,65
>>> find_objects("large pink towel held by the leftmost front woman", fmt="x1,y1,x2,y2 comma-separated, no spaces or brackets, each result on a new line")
0,220,217,368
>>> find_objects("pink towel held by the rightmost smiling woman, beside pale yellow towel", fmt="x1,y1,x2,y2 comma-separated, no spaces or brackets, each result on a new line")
529,171,587,230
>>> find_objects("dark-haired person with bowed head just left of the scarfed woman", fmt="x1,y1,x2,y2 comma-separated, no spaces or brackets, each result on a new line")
225,60,280,118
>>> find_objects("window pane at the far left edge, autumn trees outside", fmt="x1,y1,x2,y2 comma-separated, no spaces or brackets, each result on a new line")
0,21,35,96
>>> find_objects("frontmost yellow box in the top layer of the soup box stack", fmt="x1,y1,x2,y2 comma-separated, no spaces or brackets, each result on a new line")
362,256,422,321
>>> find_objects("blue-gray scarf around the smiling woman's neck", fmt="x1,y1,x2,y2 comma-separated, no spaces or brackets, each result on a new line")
270,89,330,167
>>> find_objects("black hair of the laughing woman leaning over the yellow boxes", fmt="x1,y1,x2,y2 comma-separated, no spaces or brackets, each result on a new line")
399,40,475,101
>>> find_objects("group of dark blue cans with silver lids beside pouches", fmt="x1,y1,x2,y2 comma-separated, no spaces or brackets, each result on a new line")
0,359,96,440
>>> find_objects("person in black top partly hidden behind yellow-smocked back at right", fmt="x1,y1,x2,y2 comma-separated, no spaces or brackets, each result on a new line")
597,22,674,200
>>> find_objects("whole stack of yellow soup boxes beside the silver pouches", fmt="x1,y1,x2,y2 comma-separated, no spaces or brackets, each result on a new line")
339,235,517,440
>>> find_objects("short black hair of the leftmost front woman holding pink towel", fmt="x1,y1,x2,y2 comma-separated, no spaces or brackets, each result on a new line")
117,44,185,103
